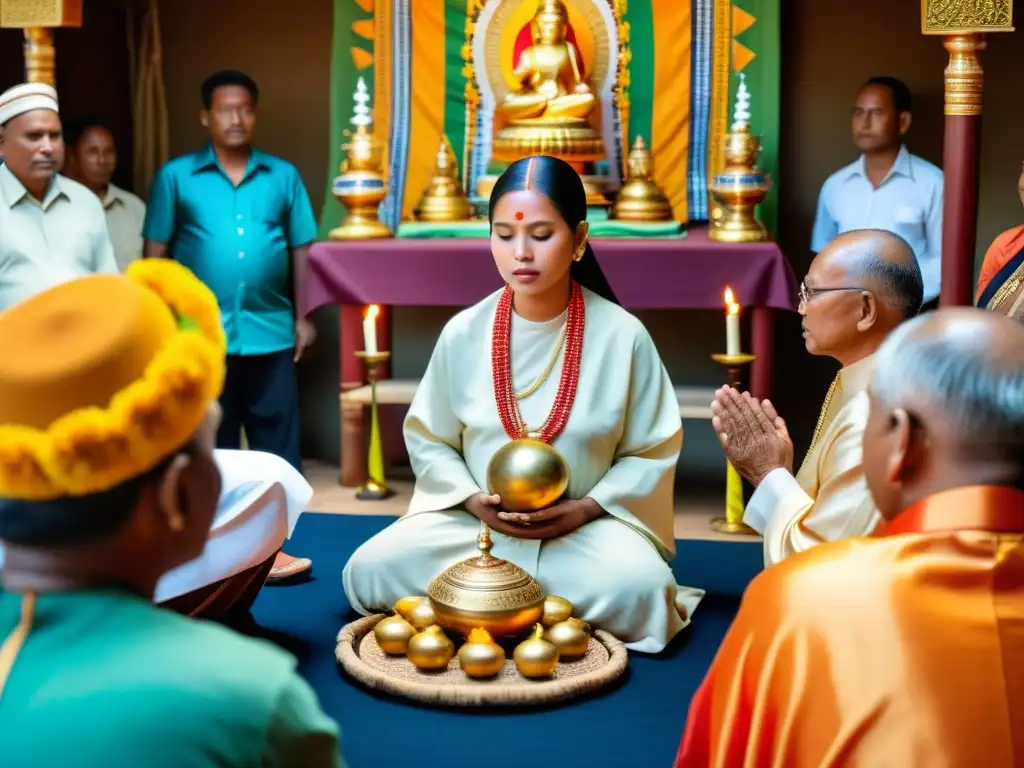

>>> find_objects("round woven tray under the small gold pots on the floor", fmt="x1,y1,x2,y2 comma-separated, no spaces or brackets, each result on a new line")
335,613,628,707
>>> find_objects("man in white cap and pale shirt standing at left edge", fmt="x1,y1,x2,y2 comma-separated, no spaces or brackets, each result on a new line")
0,83,118,311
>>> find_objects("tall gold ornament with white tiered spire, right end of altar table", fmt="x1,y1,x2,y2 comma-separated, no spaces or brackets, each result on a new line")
708,73,771,243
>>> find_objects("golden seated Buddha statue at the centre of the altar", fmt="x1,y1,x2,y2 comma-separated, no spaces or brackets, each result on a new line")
501,0,597,123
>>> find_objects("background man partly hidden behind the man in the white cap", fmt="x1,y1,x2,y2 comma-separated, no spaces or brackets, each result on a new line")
65,119,145,271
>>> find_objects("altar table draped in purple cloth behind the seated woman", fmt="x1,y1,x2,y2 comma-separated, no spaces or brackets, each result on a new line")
304,227,797,485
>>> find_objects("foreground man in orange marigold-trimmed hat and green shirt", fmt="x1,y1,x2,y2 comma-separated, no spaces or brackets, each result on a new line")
0,260,342,768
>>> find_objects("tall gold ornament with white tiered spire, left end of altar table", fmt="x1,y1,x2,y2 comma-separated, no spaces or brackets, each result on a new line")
329,77,391,240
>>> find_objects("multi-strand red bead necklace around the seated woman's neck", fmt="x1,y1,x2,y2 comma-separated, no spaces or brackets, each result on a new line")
490,282,587,443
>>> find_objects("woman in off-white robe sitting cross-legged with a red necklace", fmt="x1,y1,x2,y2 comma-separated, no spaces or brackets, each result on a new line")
343,157,702,653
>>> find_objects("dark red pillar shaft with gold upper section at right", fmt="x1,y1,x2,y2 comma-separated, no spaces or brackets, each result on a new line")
939,34,985,306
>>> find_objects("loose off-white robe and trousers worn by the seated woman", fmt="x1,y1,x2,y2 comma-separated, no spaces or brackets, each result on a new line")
343,291,703,652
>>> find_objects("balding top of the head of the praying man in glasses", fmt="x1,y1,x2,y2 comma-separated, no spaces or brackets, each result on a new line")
822,229,925,319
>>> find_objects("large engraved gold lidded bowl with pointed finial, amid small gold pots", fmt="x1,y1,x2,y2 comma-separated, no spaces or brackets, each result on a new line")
427,522,545,637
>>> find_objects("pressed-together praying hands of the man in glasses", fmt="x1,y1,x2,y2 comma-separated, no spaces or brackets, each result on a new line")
711,387,793,485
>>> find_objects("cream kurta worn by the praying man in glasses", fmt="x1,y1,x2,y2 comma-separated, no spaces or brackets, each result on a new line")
743,355,882,566
